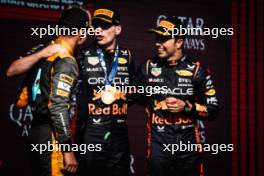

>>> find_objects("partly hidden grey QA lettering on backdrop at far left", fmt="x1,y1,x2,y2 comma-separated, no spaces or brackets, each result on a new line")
9,104,33,136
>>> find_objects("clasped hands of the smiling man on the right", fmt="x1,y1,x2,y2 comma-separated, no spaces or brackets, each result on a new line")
166,97,185,113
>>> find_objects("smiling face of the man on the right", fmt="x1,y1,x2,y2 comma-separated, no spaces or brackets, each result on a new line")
155,35,183,58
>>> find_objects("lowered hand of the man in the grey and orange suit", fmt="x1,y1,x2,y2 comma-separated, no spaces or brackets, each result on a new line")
62,152,78,173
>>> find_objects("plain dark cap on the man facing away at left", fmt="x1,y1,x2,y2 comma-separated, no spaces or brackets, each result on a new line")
58,7,89,29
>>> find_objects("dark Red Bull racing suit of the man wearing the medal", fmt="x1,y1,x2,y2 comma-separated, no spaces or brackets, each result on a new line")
75,44,134,176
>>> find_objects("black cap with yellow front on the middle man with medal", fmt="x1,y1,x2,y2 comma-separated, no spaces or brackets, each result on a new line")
92,7,120,25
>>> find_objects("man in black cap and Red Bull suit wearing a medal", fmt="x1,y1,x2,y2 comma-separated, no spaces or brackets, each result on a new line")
76,7,134,176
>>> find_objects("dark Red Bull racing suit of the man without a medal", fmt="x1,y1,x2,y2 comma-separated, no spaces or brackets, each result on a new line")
139,56,218,176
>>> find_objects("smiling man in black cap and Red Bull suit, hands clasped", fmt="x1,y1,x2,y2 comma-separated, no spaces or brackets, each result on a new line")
139,17,218,176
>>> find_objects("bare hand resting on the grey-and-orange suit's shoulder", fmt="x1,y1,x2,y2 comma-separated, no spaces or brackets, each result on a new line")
37,44,67,58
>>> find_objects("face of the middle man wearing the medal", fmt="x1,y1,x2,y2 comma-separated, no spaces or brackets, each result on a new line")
95,21,121,46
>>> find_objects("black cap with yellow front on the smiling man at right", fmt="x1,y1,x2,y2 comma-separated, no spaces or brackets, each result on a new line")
148,16,183,38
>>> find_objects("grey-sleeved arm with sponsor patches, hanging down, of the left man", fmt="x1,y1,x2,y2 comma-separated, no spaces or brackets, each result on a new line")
49,58,78,143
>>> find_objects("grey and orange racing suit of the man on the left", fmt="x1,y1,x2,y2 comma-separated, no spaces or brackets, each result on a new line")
16,40,78,176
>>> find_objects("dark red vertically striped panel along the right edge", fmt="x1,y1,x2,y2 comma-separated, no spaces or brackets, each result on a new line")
231,0,264,176
